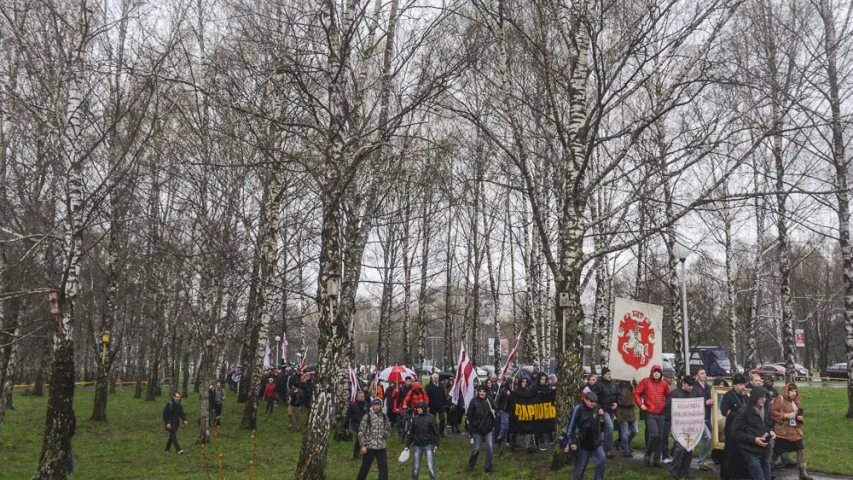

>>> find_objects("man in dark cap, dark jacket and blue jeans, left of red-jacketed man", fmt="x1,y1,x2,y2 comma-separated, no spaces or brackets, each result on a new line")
567,391,607,480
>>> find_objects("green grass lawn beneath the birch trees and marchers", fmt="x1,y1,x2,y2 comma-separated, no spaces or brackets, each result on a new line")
0,389,853,480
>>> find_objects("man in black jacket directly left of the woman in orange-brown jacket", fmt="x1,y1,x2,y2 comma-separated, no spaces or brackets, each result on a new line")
726,387,776,480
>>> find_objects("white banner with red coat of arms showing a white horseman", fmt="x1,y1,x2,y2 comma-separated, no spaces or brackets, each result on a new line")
608,298,663,382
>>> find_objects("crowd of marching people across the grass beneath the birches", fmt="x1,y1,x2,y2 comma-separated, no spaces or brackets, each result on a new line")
183,366,811,480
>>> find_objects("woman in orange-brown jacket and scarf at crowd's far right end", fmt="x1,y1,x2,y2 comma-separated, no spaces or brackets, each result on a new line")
770,382,812,480
